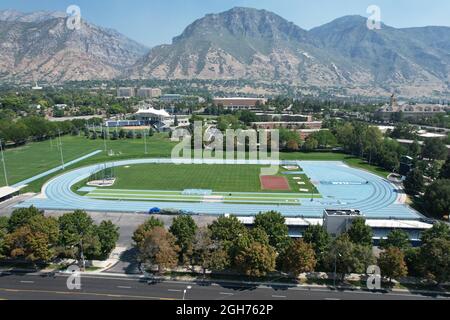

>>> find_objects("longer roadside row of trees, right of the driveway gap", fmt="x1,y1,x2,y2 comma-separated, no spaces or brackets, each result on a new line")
133,212,450,282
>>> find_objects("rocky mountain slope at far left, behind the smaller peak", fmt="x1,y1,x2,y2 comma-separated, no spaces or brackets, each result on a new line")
0,11,148,83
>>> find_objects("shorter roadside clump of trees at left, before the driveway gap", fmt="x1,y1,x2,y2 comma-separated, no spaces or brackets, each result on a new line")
0,207,119,263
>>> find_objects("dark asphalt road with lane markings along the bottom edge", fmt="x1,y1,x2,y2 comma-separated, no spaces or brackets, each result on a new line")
0,274,448,301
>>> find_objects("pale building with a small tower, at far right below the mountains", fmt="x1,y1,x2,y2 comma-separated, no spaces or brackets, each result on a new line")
375,94,446,121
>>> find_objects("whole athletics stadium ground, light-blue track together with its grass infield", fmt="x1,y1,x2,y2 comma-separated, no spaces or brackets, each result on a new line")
17,158,422,220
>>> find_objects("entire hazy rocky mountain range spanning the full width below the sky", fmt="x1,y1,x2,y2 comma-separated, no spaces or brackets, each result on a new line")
0,7,450,96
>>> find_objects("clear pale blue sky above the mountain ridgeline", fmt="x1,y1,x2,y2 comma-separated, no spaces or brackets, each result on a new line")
0,0,450,46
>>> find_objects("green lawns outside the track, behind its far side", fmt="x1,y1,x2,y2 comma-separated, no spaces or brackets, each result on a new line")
0,134,388,192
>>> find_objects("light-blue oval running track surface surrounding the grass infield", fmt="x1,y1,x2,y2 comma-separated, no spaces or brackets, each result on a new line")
14,159,421,220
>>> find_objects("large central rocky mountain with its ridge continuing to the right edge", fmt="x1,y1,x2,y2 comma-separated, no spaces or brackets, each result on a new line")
128,8,450,94
